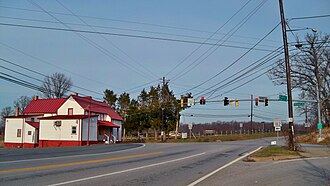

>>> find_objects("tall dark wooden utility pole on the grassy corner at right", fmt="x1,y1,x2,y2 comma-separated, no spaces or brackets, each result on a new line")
279,0,296,150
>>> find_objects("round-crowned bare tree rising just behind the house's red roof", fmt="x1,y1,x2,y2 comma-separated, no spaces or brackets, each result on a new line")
42,72,72,98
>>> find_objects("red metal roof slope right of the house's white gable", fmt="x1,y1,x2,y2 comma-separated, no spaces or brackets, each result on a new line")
72,95,123,121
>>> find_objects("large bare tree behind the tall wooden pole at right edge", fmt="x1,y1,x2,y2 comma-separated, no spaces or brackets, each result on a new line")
269,33,330,124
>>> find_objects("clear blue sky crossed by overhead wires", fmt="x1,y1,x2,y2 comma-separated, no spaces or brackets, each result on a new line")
0,0,330,122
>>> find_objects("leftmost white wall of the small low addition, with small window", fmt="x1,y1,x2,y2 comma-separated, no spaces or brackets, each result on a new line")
4,118,24,143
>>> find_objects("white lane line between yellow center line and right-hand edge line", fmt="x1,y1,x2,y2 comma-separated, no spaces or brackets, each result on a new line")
49,152,206,186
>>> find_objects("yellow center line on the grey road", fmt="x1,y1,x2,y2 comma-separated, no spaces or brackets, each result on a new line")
0,152,161,173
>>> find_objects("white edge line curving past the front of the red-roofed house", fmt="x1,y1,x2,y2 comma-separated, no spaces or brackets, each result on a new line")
0,144,146,164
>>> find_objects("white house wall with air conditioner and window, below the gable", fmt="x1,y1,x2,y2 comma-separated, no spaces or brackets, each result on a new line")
39,119,81,141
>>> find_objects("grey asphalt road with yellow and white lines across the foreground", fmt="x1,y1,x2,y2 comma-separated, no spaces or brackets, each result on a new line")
0,138,330,186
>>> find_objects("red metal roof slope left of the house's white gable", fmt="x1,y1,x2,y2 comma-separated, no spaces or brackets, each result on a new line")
23,98,67,114
